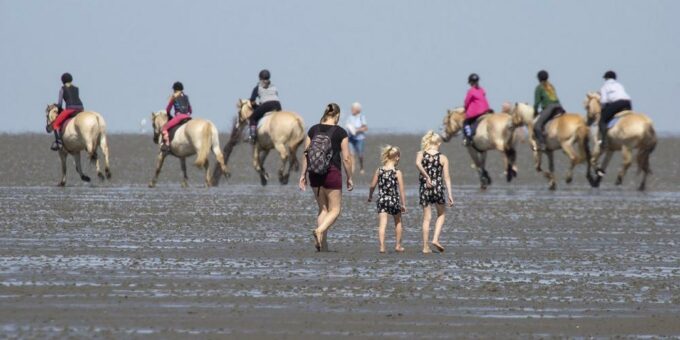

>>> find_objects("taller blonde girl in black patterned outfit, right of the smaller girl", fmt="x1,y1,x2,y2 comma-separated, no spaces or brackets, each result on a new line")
416,131,453,254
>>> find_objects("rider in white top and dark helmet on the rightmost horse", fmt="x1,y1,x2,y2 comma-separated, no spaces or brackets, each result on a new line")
598,70,633,145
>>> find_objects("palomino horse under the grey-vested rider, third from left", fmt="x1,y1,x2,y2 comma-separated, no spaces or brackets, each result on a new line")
226,99,305,185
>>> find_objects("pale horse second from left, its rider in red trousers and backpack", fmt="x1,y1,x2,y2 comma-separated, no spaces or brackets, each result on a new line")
149,110,229,188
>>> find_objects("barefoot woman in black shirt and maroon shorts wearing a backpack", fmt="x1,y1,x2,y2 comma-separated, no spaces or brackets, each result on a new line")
298,103,354,251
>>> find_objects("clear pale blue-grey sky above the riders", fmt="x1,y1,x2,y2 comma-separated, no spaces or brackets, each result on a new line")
0,0,680,134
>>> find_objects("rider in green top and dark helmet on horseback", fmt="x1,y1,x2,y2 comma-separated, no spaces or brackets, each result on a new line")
534,70,565,151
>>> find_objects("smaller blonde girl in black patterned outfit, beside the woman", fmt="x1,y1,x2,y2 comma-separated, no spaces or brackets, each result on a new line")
368,145,406,253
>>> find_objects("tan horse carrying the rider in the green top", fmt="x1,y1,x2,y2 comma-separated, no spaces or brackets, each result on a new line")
510,103,593,190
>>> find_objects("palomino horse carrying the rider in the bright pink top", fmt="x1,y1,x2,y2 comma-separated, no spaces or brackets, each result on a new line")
442,107,517,189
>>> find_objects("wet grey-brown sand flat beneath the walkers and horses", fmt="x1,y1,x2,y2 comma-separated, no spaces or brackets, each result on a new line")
0,135,680,339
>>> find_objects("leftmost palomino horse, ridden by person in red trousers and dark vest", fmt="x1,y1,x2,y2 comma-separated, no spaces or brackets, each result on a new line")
45,104,111,186
